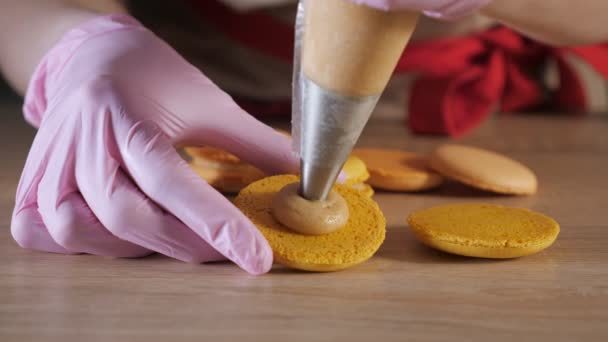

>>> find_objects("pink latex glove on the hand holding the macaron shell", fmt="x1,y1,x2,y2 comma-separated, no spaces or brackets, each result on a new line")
11,16,298,274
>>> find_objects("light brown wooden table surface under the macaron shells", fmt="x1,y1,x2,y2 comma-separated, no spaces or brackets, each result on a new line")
0,106,608,342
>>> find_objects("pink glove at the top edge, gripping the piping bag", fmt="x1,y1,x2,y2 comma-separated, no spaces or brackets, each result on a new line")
351,0,492,20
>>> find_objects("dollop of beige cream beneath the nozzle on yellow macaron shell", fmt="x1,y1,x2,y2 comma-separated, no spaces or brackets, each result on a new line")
272,182,349,235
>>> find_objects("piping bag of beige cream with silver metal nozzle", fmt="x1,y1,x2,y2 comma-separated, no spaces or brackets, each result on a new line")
292,0,419,201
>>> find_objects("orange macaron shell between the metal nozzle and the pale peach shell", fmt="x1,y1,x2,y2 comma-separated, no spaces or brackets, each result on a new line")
353,148,443,191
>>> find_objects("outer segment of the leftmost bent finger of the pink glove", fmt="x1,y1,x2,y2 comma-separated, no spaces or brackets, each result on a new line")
11,206,77,254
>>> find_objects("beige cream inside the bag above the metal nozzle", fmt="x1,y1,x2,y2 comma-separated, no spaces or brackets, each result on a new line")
302,0,418,96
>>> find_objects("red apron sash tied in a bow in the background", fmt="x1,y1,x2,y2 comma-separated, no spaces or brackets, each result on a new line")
191,1,608,136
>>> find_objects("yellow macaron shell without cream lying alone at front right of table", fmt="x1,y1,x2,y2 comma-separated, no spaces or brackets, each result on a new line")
408,203,560,259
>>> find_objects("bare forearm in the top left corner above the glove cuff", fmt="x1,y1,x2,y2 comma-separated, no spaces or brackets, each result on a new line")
0,0,126,94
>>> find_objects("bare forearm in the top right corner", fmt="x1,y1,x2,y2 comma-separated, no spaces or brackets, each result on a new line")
481,0,608,46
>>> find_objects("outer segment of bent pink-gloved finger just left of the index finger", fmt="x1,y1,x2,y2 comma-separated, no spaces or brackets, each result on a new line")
76,148,223,263
